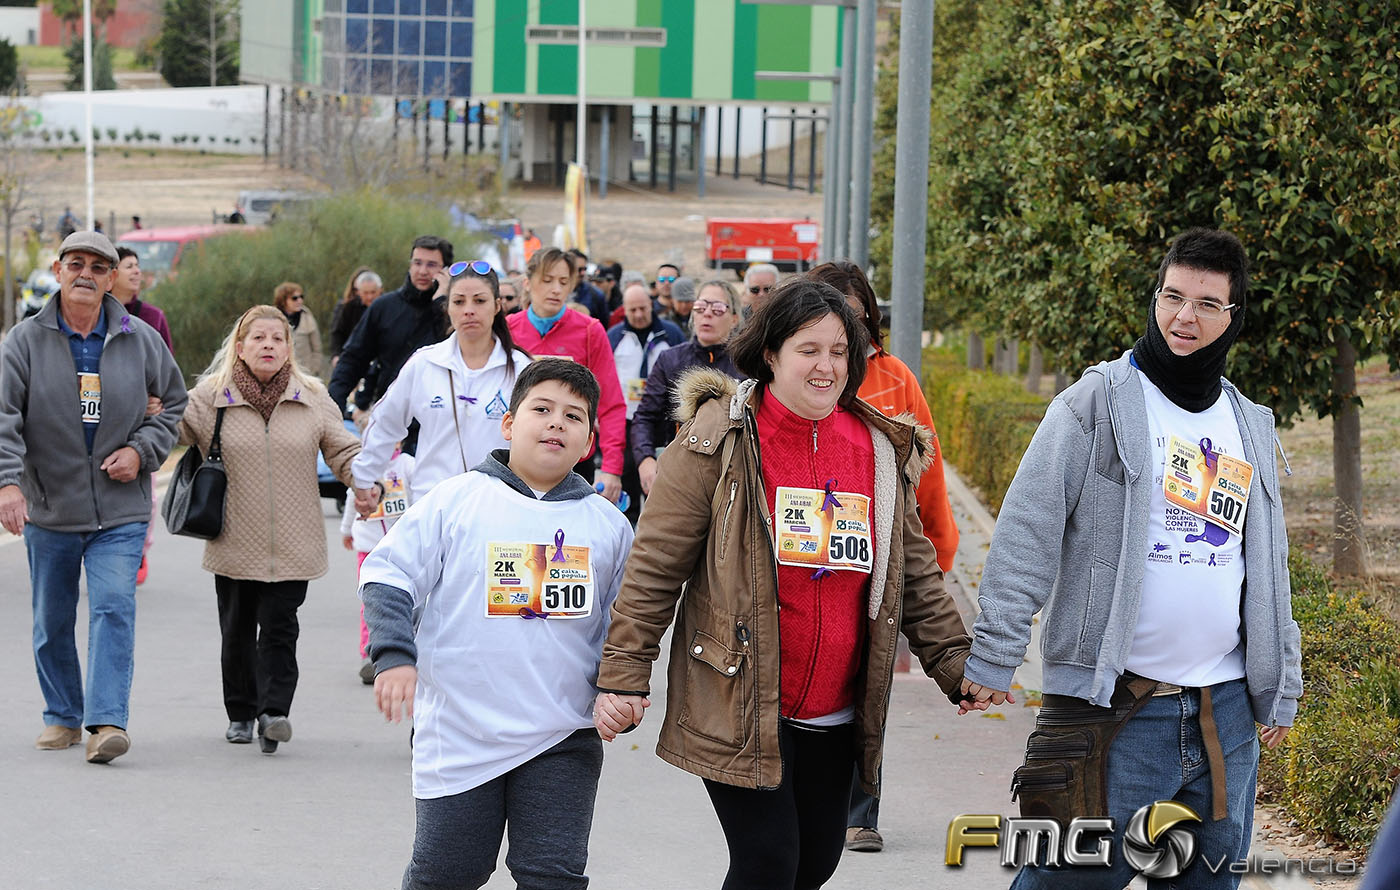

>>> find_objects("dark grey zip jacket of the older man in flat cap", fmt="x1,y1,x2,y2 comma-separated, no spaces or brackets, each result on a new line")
0,295,189,532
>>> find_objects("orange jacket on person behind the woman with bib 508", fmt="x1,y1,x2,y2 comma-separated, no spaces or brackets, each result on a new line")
857,347,958,572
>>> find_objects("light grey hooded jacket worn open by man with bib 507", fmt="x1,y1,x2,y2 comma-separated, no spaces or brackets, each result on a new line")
965,353,1302,726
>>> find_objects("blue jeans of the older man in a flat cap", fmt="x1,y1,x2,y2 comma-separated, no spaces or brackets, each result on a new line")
24,522,147,729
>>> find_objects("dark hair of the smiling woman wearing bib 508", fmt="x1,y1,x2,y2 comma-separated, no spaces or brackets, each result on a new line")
729,278,868,409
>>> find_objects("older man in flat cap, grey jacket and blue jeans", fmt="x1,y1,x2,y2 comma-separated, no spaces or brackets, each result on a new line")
0,232,188,763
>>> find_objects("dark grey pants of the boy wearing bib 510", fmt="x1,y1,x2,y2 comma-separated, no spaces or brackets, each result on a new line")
403,729,603,890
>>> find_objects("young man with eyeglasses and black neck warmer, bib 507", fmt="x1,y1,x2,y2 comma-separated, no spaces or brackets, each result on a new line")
963,228,1302,890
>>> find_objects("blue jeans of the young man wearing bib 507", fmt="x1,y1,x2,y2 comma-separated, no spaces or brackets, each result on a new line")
1011,680,1259,890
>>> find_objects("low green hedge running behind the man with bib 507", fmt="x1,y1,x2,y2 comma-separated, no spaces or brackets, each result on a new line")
924,350,1400,848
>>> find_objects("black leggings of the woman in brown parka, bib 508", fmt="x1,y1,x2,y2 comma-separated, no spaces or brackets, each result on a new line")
704,721,855,890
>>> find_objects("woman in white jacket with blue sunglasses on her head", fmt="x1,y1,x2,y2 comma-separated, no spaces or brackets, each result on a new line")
351,260,531,512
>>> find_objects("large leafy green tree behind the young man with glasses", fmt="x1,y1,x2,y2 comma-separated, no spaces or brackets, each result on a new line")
873,0,1400,574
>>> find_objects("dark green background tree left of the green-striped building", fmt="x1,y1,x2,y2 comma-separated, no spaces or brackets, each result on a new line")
155,0,239,87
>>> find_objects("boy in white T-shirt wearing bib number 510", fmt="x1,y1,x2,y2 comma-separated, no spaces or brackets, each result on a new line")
360,360,633,890
